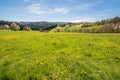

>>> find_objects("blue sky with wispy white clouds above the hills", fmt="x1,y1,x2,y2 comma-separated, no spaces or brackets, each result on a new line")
0,0,120,22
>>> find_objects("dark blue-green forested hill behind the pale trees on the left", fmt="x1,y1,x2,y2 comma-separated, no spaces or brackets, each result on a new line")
0,20,65,30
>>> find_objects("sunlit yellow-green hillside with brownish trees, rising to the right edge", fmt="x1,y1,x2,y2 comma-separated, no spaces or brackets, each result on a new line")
56,17,120,33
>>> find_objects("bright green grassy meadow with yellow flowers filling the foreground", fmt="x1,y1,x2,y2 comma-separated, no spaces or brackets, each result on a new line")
0,30,120,80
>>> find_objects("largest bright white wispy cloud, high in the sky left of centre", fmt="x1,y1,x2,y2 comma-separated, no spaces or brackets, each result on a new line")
27,3,69,14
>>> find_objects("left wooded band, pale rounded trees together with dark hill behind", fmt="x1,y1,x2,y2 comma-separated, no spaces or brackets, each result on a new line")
0,20,57,31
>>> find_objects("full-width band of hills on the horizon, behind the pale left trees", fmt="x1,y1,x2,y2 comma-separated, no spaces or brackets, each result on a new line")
0,17,120,33
